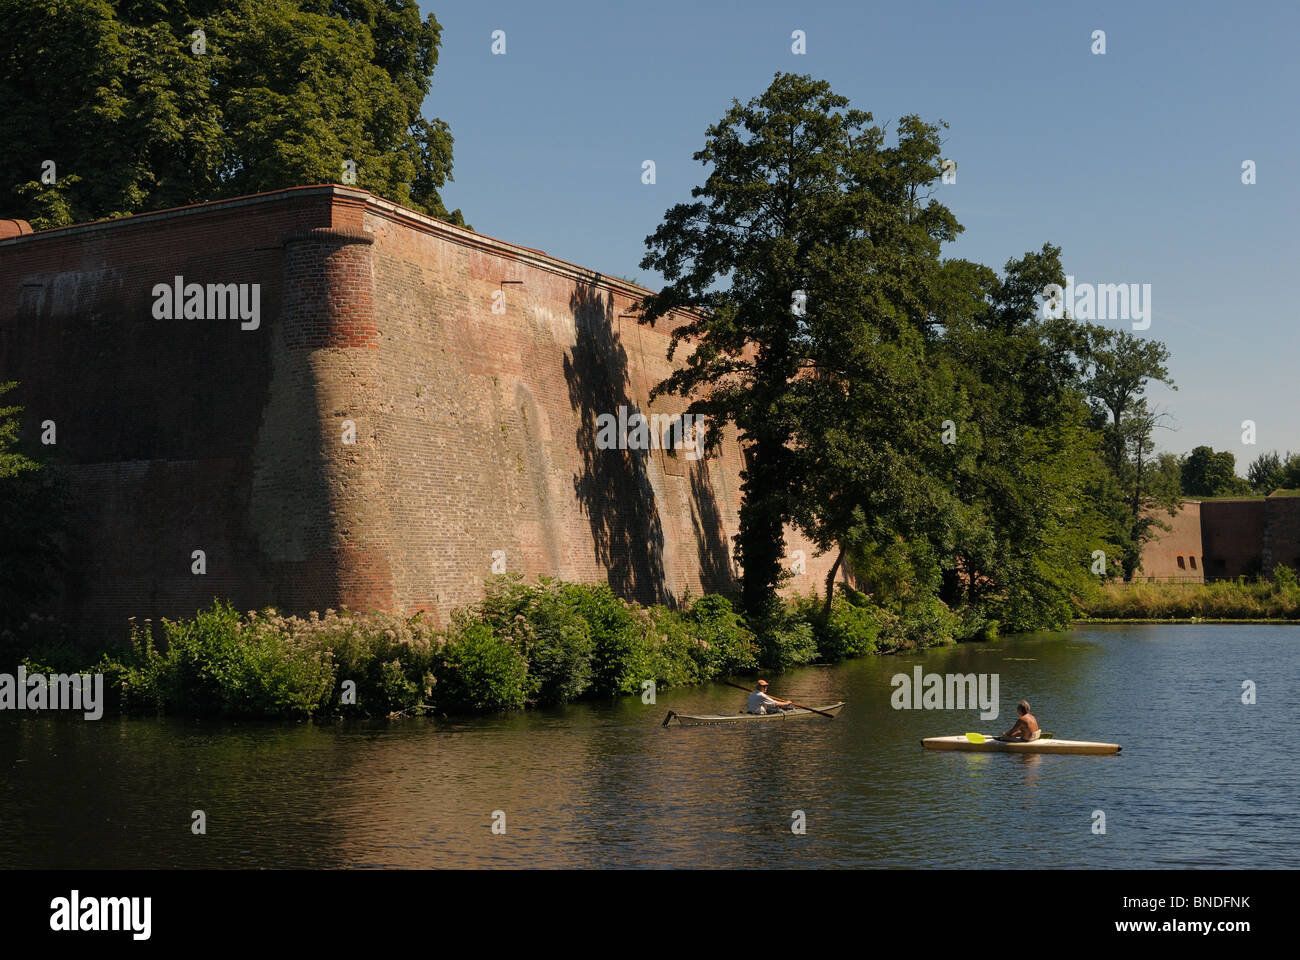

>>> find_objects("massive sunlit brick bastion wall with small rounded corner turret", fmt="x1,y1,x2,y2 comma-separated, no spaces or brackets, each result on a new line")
0,186,832,632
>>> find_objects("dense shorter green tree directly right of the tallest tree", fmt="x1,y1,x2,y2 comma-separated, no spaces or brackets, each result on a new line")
933,245,1112,630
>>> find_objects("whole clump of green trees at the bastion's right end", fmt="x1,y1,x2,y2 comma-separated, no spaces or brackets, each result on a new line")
641,74,1177,630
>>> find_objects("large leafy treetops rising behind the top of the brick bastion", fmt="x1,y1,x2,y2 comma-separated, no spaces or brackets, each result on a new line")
0,0,464,228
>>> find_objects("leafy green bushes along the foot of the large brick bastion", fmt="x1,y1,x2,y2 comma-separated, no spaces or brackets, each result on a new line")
10,576,996,717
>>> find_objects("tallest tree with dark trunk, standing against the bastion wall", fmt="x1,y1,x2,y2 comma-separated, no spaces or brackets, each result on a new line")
641,74,958,611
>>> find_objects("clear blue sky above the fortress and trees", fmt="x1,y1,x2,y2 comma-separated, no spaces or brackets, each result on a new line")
420,0,1300,472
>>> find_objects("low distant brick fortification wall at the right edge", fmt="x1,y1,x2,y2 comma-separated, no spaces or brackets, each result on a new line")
1138,494,1300,583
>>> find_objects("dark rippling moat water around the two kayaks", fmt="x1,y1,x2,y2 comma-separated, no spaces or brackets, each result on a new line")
0,624,1300,869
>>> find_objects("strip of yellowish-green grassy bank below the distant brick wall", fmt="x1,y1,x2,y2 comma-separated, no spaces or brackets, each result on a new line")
1080,567,1300,622
